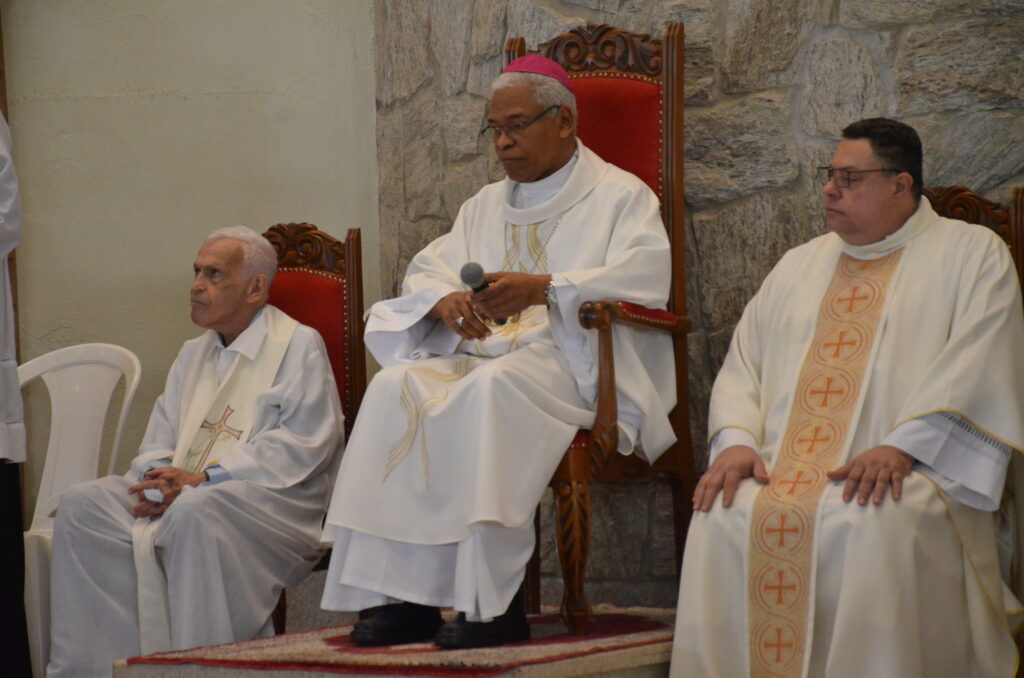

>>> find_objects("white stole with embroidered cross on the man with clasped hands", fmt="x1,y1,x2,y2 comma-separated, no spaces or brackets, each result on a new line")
132,305,299,654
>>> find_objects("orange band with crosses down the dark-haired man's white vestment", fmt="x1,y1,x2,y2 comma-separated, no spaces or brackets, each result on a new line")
748,250,902,678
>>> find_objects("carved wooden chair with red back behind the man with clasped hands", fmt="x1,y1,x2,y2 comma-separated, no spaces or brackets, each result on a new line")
263,223,367,633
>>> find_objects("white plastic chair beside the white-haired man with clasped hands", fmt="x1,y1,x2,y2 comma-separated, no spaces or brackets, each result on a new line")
17,344,141,678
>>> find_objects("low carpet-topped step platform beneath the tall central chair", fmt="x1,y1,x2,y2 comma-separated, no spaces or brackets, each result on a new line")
114,605,675,678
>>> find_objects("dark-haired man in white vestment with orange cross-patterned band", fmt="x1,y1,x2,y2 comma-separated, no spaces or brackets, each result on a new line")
672,119,1024,678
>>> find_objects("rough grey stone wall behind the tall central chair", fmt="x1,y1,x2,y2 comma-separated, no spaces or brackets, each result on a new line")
376,0,1024,605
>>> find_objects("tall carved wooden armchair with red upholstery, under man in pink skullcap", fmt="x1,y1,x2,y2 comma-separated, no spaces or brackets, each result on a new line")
505,24,695,635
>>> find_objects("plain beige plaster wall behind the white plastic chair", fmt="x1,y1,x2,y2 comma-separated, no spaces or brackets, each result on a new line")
0,0,379,520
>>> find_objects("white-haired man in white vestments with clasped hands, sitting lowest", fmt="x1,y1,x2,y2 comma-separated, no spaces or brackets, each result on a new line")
47,226,343,678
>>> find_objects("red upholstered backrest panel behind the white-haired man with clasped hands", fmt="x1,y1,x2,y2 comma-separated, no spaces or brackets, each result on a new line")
270,268,350,409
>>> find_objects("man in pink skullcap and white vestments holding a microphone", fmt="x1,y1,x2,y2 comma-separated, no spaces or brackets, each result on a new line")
322,56,675,647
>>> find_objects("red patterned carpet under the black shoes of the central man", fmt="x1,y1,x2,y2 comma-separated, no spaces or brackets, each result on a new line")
128,610,672,676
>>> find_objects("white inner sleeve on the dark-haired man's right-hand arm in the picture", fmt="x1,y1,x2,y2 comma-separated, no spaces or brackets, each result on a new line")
883,412,1013,511
